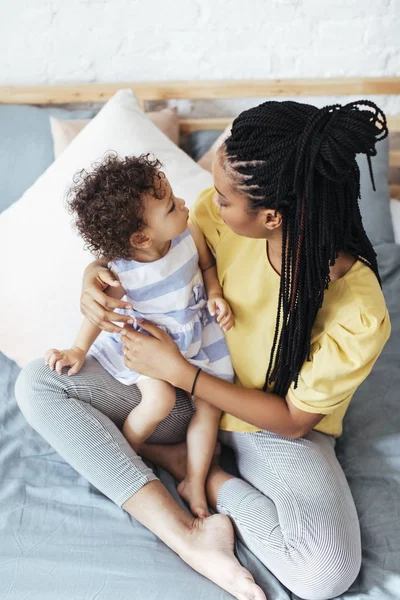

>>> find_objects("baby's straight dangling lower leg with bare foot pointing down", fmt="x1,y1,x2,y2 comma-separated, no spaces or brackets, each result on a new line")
178,398,221,519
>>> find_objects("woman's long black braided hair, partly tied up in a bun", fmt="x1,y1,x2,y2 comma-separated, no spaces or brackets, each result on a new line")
221,100,388,397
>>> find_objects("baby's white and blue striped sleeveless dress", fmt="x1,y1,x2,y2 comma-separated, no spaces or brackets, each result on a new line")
90,230,233,385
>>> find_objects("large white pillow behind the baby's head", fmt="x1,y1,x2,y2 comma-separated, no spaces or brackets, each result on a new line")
0,90,212,366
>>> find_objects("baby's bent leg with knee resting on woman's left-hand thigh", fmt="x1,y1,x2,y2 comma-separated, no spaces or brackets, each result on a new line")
122,379,176,452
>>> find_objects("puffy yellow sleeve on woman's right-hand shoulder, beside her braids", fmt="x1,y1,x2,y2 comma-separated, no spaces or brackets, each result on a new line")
288,306,390,415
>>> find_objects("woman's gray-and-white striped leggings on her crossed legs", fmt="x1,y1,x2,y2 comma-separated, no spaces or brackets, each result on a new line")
16,358,361,600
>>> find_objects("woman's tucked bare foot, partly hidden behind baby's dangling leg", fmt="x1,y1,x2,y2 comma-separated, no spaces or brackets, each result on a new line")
140,442,221,481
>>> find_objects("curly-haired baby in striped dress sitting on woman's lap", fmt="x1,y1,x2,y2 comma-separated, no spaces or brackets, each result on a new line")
45,154,234,518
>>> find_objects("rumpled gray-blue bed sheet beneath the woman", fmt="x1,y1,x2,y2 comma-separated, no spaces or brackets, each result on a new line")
0,243,400,600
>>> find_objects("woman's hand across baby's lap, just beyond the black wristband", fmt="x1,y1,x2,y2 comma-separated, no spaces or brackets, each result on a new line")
121,319,196,390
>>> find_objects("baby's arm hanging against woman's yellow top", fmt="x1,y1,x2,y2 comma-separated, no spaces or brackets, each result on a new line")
188,223,235,331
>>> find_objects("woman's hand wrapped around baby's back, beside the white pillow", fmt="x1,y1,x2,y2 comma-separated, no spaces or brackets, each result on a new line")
81,261,132,333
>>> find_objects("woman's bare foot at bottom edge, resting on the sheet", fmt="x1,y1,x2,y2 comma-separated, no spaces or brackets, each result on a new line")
178,515,266,600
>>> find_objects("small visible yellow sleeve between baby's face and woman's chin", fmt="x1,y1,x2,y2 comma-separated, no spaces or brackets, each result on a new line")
190,187,227,252
